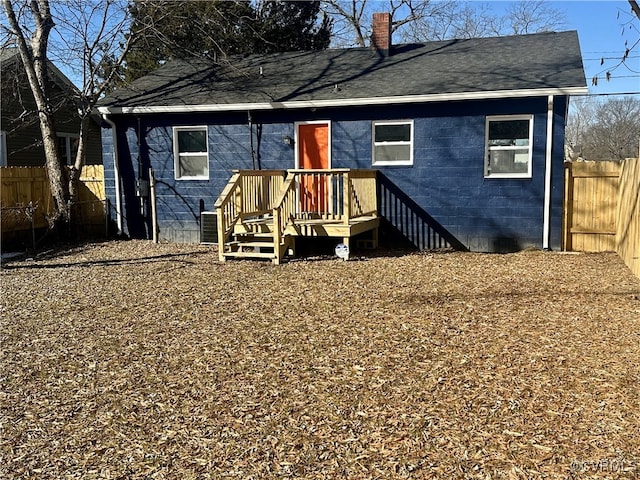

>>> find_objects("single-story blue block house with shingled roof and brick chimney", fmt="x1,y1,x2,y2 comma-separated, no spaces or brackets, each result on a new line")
98,14,587,258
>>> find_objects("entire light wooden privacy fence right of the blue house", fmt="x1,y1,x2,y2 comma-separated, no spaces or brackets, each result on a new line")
563,159,640,276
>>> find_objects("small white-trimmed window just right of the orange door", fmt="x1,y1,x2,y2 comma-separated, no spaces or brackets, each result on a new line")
372,120,413,165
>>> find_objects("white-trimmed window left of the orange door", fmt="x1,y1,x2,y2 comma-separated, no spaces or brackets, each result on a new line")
173,127,209,180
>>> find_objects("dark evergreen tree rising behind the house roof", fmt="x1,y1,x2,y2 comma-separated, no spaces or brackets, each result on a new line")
122,0,331,82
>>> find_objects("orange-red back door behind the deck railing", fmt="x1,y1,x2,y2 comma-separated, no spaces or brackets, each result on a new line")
298,123,329,214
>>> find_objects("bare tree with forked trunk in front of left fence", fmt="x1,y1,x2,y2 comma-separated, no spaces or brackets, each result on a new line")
1,0,134,232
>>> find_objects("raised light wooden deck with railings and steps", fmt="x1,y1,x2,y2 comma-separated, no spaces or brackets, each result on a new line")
215,169,380,264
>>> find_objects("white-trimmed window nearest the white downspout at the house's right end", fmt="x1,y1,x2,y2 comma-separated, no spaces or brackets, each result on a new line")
484,115,533,178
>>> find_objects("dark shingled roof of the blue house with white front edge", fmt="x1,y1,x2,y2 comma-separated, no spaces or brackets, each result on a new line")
100,31,587,113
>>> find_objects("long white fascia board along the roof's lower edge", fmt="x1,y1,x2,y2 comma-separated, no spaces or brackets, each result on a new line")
98,87,588,115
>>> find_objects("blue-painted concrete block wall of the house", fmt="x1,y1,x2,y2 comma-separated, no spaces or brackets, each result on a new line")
103,97,566,251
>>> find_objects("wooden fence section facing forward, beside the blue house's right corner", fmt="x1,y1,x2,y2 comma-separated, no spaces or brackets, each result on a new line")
564,162,622,252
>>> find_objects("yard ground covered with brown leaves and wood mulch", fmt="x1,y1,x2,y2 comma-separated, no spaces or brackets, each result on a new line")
0,241,640,479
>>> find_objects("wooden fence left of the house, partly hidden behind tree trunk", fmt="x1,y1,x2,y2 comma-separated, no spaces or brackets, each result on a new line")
0,165,106,248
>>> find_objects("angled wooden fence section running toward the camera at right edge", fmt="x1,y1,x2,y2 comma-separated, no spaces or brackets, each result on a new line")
616,159,640,277
